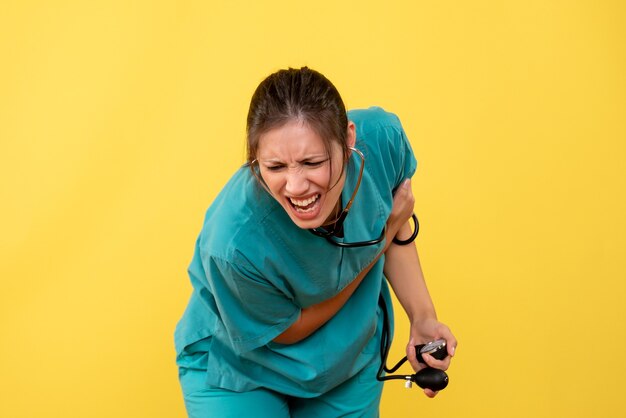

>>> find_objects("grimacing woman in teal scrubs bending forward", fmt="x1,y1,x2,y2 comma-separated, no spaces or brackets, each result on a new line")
175,67,456,418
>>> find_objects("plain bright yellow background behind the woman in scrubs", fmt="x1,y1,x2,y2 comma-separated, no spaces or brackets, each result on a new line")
0,0,626,418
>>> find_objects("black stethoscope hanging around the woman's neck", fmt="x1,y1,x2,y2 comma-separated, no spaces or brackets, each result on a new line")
309,147,419,248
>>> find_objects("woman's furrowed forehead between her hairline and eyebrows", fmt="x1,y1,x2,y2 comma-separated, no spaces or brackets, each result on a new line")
257,121,336,160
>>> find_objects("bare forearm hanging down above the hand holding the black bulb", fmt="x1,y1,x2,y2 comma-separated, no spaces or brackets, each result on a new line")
384,223,437,323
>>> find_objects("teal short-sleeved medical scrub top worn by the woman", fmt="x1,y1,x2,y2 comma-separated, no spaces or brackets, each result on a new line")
175,108,417,397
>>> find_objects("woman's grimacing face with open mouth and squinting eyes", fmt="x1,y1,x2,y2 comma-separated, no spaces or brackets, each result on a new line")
257,121,355,229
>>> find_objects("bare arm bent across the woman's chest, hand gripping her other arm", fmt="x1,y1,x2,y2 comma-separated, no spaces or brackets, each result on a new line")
274,180,415,344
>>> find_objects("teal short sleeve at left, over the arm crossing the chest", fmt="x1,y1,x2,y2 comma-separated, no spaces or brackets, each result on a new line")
204,257,300,354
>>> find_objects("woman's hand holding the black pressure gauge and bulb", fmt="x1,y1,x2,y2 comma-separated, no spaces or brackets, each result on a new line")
406,318,457,398
